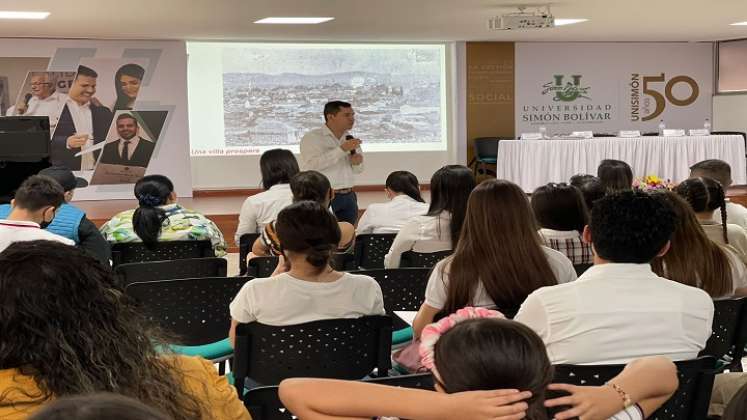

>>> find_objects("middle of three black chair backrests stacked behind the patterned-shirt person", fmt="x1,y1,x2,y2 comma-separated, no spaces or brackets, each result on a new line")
114,257,228,286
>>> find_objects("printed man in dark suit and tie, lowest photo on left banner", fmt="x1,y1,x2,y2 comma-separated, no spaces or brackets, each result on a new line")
99,113,156,168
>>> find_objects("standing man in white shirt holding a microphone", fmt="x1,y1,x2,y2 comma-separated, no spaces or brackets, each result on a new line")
301,101,363,225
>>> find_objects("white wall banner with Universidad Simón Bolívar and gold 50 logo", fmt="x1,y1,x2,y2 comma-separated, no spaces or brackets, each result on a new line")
516,43,713,135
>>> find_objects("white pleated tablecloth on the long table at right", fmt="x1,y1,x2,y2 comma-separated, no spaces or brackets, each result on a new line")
496,136,747,192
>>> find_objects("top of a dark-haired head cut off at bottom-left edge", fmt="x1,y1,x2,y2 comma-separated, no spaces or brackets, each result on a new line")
29,392,170,420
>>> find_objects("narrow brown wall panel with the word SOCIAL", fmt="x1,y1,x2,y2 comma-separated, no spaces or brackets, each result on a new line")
467,42,514,166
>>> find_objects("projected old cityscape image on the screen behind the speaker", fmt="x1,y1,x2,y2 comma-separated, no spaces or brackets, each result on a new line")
223,44,444,147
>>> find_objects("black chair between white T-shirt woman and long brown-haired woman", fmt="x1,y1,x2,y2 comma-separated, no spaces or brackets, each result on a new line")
354,268,431,330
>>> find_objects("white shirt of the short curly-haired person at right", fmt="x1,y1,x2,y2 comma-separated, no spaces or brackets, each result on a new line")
514,263,713,365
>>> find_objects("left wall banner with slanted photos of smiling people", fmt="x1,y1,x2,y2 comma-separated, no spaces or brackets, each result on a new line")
0,39,192,200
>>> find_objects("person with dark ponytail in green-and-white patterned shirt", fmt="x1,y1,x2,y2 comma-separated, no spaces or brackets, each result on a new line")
101,175,226,257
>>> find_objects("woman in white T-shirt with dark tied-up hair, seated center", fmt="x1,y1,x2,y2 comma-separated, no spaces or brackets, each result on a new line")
230,201,384,342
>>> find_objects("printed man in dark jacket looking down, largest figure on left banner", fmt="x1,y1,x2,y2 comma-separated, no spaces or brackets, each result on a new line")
52,66,112,171
